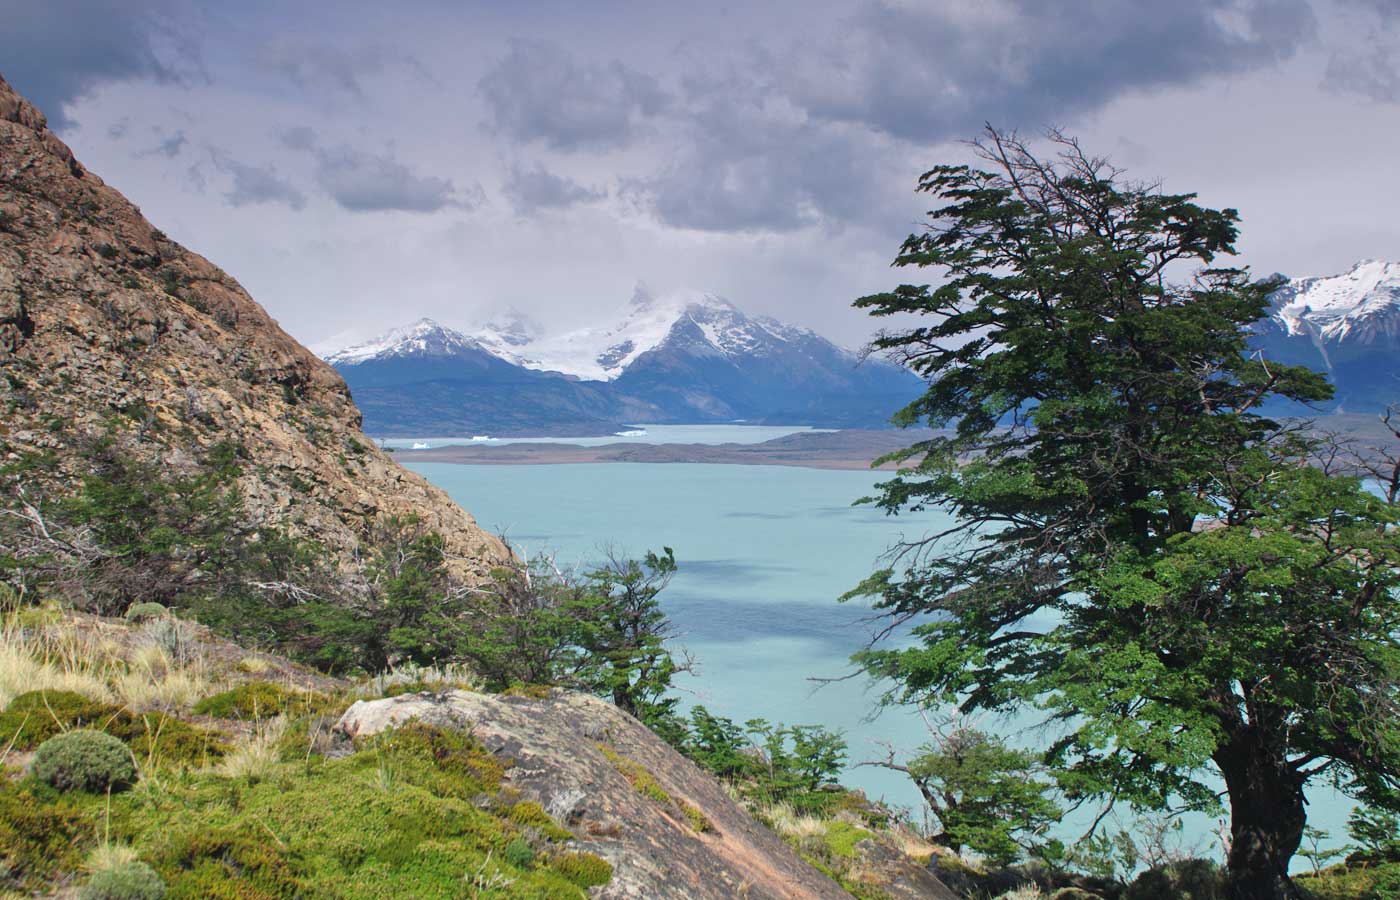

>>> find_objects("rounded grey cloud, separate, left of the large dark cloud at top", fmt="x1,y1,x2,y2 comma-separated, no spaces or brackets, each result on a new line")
477,39,666,150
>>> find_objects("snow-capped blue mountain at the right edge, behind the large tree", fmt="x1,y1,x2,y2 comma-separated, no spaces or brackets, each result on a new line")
1254,259,1400,412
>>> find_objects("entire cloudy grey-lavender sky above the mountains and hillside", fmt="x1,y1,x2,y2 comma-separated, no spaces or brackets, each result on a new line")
0,0,1400,347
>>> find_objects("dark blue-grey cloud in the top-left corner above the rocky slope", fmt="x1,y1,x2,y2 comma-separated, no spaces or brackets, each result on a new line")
0,0,200,130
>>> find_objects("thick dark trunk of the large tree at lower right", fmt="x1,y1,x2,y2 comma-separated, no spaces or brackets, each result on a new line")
1215,726,1308,900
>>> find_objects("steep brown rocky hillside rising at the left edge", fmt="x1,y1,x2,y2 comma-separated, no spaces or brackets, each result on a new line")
0,72,507,577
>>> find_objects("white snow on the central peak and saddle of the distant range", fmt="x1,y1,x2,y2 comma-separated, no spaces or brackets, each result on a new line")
475,286,854,381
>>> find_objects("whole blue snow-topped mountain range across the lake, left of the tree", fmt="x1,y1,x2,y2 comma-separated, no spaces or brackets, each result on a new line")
325,288,921,435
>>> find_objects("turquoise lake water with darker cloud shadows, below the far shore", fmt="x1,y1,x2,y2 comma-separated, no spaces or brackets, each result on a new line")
410,453,1348,852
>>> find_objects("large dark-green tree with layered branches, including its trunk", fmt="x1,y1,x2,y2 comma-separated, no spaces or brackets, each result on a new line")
851,129,1400,900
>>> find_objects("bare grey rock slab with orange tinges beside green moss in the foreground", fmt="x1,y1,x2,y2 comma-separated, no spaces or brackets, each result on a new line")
337,690,856,900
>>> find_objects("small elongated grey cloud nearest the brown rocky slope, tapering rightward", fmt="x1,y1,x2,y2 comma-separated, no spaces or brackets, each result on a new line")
281,126,484,213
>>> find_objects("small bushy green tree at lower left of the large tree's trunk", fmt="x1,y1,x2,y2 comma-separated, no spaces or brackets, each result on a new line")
869,724,1061,865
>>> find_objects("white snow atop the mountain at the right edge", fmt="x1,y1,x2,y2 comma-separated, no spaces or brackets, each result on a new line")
1271,259,1400,344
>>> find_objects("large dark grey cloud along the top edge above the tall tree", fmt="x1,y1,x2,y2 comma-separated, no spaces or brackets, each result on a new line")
776,0,1316,141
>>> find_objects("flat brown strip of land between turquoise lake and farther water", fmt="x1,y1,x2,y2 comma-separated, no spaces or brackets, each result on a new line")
395,430,930,469
